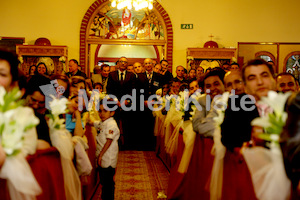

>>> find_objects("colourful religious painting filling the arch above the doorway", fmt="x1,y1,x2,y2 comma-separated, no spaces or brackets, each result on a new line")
89,4,165,40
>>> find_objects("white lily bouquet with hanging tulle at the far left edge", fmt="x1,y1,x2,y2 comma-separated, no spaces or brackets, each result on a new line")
0,87,41,200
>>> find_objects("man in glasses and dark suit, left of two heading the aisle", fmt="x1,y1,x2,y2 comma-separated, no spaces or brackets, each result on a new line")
106,57,136,149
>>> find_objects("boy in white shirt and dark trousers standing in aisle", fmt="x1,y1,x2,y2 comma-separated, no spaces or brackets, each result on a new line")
94,101,120,200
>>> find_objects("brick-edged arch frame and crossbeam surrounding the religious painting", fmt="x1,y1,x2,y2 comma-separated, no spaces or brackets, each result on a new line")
79,0,173,74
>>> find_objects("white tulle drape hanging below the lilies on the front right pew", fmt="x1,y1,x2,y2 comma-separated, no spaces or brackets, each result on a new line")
244,144,291,200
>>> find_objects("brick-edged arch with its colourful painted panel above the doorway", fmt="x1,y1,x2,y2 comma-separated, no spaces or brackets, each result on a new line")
79,0,173,74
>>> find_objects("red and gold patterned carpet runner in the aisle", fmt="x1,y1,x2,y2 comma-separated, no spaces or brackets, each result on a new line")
92,151,169,200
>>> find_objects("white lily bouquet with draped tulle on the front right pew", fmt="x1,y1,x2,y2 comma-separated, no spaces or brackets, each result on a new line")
244,91,291,200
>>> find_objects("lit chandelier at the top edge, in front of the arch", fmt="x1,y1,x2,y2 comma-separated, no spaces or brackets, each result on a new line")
111,0,154,10
